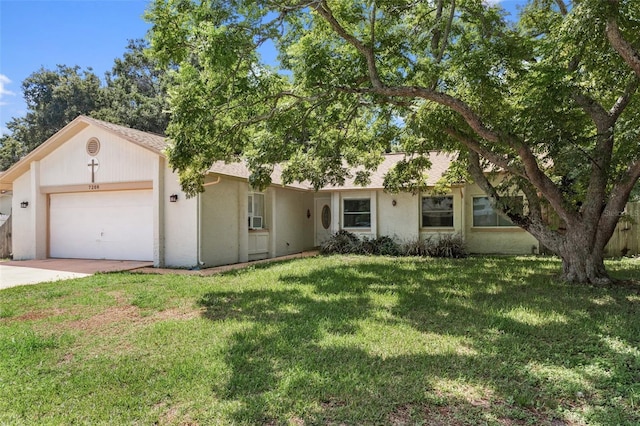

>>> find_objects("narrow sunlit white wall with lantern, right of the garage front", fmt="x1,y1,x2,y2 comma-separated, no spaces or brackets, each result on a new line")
161,165,198,267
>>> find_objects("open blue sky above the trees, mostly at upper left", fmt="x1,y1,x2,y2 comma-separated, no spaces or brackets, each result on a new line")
0,0,523,133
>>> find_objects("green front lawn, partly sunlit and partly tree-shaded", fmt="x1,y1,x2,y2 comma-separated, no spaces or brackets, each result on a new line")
0,256,640,425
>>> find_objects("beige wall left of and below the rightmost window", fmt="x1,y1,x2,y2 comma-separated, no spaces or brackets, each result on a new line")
464,185,538,254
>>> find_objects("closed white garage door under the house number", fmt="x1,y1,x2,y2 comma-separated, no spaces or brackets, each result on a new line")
49,190,153,260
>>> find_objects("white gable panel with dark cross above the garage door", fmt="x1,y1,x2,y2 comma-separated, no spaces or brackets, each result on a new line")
40,126,158,186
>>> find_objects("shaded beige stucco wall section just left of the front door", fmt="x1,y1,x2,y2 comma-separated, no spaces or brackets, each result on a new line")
271,188,314,256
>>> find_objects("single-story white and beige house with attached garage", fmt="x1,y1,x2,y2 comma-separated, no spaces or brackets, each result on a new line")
0,116,538,267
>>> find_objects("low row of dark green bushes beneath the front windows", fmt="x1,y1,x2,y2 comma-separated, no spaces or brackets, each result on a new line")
320,230,467,258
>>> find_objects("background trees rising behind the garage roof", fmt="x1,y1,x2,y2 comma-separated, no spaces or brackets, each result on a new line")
0,40,169,170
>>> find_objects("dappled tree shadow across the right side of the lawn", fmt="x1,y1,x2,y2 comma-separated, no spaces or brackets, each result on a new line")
201,257,640,424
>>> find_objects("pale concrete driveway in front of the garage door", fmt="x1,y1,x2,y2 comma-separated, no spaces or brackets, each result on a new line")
0,259,153,290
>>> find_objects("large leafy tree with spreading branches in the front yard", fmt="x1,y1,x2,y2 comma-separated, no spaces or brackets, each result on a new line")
148,0,640,283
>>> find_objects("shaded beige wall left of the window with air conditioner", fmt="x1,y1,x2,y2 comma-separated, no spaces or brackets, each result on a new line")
200,178,242,266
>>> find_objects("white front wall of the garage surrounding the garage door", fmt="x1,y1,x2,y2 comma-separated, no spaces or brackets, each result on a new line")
12,126,169,264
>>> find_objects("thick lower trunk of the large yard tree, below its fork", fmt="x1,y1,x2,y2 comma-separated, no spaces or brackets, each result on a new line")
557,229,612,285
